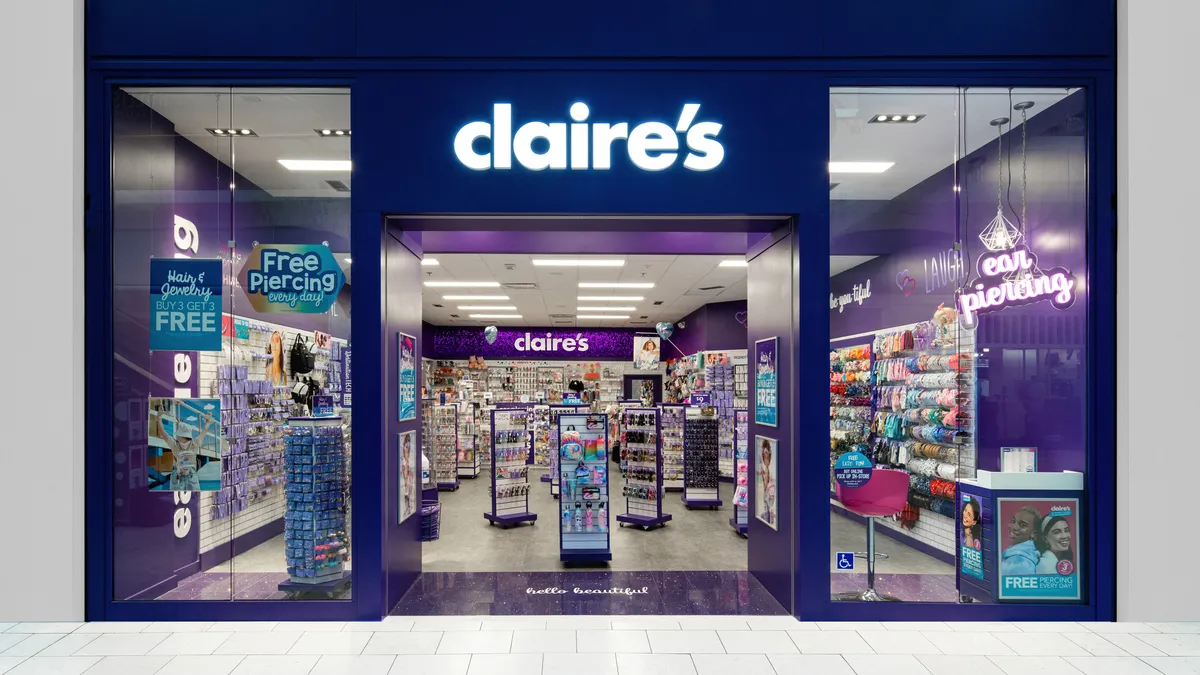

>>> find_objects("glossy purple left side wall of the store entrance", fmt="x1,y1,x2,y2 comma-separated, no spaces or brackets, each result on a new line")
383,231,425,610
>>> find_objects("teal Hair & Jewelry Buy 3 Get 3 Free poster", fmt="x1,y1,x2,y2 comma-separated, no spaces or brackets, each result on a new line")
150,258,223,352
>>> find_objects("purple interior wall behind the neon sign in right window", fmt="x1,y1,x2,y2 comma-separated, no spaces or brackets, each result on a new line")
829,92,1087,471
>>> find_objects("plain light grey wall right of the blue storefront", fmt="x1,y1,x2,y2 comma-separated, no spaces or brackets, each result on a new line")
1117,0,1200,621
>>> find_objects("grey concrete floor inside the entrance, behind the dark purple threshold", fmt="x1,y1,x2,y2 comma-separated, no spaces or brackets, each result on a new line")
422,470,746,572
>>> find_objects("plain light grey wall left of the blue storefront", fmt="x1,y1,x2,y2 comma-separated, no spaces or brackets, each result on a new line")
0,0,84,621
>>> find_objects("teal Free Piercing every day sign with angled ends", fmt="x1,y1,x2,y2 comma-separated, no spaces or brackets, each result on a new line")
238,244,346,313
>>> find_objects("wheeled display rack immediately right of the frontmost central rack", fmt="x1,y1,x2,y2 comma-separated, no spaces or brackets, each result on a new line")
617,408,671,530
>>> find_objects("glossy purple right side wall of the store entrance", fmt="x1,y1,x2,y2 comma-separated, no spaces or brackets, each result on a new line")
746,234,798,609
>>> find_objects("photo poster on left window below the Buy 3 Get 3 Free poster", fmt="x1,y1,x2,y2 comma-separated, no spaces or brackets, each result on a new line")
146,398,222,492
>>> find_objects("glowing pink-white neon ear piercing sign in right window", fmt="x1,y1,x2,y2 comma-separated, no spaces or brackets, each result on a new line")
959,244,1075,329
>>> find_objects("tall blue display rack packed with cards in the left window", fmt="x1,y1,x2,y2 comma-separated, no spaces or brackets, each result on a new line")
280,417,350,592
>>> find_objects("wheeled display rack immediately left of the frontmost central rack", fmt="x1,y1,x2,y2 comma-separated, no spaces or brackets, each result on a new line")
484,408,538,527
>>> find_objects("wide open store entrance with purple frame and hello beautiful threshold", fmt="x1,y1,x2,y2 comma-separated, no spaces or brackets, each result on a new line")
385,216,793,615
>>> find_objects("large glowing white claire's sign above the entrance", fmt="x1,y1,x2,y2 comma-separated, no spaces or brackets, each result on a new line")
454,101,725,172
